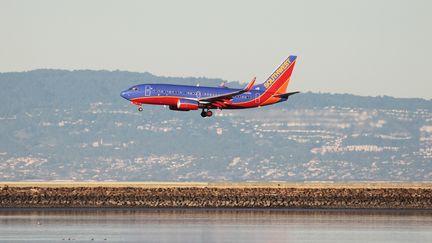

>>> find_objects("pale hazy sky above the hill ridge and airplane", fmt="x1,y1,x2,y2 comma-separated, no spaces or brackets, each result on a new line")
0,0,432,99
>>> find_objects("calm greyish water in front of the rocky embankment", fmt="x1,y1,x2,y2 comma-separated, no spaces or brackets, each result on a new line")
0,209,432,242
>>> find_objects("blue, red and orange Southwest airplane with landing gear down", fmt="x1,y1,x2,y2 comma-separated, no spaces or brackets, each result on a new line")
120,56,299,117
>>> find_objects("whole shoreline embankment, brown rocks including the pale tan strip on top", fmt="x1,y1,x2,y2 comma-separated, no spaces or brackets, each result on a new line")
0,181,432,210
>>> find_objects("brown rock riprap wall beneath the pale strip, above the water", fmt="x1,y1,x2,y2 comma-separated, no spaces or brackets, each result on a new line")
0,185,432,209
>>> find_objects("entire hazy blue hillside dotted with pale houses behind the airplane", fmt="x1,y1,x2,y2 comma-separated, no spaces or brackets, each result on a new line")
0,70,432,181
